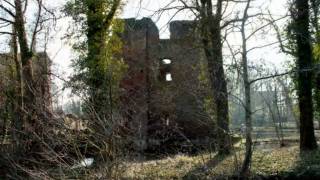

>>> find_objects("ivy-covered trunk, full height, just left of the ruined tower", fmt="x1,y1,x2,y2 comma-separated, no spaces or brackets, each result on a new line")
83,0,120,164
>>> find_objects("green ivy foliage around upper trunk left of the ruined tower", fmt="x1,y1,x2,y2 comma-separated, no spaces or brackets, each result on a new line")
64,0,126,117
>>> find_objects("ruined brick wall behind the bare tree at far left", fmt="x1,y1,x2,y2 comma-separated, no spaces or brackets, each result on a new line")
0,52,52,134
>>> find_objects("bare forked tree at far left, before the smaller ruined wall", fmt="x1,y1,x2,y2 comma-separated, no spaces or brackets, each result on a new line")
0,0,54,141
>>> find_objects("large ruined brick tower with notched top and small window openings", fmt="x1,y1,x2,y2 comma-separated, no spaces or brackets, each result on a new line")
121,18,214,150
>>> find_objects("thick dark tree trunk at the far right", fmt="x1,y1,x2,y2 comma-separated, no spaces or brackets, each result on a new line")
293,0,317,150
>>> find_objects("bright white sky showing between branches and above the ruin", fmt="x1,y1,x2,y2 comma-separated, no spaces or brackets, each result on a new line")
0,0,288,104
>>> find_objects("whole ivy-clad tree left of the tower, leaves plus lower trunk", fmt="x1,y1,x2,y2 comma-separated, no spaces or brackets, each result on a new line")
65,0,126,164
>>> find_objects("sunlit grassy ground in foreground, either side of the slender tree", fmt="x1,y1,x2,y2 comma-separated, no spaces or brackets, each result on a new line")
121,146,320,179
